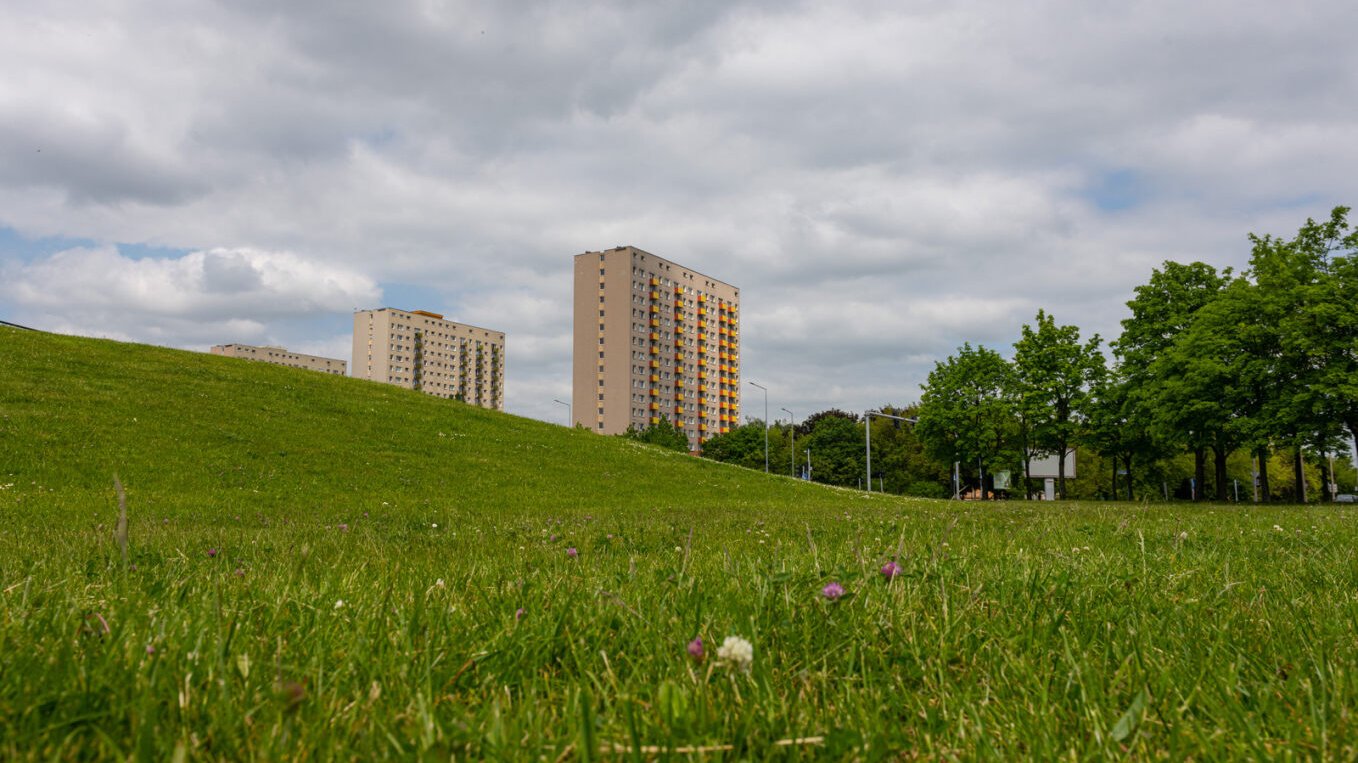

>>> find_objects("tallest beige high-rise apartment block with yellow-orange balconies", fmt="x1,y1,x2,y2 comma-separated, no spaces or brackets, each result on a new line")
572,246,740,451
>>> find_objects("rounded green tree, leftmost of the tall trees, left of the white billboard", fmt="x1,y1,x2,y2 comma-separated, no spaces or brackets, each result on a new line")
915,343,1016,491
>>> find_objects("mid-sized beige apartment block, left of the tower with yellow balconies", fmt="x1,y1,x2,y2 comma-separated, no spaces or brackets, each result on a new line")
353,307,505,410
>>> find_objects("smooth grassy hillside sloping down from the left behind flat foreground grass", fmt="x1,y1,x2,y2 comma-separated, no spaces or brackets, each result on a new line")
0,323,869,516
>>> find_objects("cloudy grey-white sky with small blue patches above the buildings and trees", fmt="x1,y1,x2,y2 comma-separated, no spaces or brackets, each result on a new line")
0,0,1358,421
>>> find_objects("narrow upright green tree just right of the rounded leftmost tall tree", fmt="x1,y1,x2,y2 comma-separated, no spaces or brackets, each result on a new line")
1013,310,1104,498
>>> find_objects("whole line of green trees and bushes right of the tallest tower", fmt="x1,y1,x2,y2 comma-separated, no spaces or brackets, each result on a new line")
684,206,1358,502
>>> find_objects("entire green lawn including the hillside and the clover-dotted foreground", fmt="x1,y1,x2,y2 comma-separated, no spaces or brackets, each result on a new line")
0,330,1358,760
